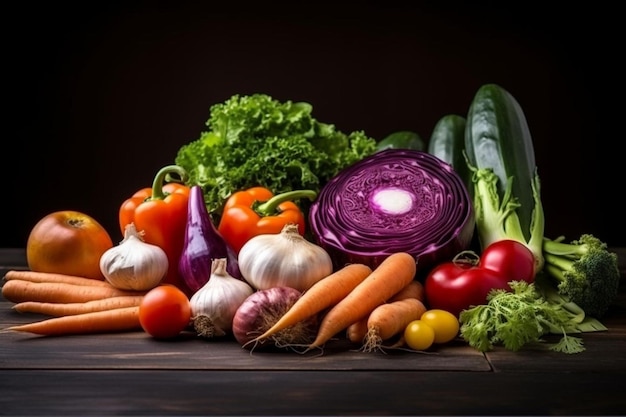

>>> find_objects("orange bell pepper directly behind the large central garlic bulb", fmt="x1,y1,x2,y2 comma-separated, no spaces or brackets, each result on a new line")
217,187,317,254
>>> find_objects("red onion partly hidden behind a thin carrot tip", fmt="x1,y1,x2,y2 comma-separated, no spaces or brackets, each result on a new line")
232,286,318,350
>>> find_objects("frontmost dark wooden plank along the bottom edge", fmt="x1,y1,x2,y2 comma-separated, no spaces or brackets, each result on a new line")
0,370,626,416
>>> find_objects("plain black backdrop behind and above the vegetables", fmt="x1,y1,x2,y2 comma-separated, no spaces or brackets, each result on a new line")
0,1,626,247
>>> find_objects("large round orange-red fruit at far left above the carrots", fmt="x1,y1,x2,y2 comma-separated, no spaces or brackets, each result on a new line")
26,210,113,280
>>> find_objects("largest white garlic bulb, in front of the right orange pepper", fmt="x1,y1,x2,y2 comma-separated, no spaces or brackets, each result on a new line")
238,224,333,292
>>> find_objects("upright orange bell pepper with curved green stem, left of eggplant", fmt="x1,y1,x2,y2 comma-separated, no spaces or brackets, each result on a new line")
119,165,190,293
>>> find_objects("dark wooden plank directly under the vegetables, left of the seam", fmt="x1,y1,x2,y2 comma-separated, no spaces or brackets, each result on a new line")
0,301,491,372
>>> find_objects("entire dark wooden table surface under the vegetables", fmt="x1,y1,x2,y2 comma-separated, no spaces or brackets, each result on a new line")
0,248,626,416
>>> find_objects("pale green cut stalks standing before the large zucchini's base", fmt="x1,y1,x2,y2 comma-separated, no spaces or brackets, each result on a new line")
468,160,545,271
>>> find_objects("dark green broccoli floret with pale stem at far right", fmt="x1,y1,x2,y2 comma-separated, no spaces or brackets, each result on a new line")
543,234,620,318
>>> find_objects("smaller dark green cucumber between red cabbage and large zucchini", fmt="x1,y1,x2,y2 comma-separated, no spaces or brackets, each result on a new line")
428,114,466,193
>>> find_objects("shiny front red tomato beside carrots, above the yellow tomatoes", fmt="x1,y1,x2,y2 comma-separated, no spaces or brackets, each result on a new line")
424,261,510,317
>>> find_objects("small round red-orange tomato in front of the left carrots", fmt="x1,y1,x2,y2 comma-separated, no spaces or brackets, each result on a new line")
139,284,191,339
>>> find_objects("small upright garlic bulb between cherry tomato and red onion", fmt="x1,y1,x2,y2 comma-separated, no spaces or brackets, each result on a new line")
189,258,254,338
